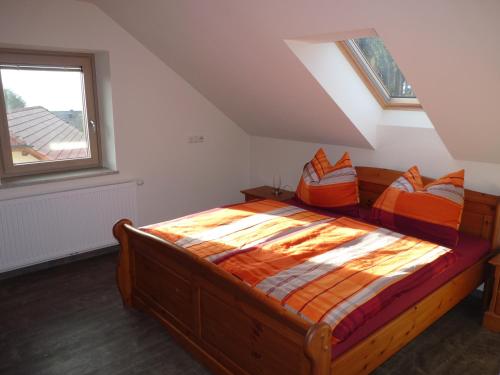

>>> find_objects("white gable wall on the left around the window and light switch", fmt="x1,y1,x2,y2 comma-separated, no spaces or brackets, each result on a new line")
0,0,249,224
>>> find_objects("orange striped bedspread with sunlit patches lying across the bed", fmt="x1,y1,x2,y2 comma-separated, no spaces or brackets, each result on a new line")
142,200,453,342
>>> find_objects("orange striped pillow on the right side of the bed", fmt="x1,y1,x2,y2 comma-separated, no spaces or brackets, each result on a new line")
371,167,464,246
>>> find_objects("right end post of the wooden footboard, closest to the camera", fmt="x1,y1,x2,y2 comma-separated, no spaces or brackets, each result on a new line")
306,323,332,375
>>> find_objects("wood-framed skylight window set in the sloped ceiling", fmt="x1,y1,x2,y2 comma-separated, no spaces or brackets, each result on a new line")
340,37,421,108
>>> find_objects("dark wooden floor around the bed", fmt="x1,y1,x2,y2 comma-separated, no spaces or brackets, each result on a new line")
0,254,500,375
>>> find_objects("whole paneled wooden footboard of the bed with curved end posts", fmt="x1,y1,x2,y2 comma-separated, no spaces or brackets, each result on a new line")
114,220,331,375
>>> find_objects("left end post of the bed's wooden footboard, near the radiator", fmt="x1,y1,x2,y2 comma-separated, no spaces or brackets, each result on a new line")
113,219,132,307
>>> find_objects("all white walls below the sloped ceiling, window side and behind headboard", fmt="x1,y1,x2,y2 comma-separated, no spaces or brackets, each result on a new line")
0,0,500,247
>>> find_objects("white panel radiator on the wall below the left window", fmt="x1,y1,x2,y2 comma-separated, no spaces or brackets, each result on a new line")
0,182,137,272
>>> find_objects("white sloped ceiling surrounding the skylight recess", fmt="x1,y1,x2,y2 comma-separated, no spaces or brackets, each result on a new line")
83,0,500,162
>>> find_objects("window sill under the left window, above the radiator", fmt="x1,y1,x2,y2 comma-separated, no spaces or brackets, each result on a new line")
0,168,118,189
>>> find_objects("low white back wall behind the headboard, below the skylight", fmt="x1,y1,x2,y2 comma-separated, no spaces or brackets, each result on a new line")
250,125,500,195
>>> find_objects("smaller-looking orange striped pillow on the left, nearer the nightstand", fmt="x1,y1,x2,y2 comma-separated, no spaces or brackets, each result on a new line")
296,148,359,215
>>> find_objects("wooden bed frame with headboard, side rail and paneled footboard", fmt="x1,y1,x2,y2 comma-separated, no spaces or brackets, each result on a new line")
113,167,500,375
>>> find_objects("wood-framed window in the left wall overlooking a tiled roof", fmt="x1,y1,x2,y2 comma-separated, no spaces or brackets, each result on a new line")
0,50,100,177
